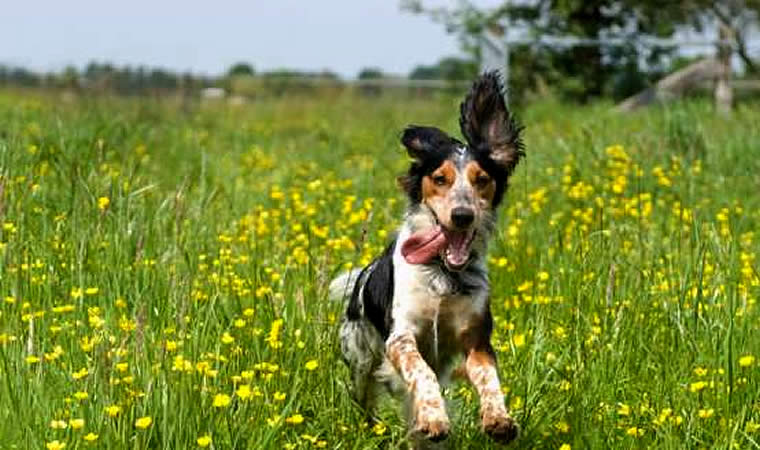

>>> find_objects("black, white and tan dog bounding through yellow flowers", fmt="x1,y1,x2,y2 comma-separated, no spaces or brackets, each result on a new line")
330,72,524,442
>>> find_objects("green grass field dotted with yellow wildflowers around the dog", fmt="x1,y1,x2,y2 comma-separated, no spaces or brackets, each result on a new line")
0,89,760,450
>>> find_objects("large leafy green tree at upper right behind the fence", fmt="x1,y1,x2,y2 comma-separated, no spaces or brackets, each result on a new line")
402,0,760,100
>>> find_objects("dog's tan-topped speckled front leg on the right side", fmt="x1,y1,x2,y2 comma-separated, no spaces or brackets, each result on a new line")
465,344,519,443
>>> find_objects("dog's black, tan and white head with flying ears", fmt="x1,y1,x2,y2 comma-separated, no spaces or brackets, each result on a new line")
400,72,524,270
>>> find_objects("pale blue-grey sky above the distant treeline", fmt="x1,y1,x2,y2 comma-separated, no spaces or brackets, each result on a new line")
0,0,504,78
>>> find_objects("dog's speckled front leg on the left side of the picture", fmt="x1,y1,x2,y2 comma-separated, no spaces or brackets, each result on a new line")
385,331,449,441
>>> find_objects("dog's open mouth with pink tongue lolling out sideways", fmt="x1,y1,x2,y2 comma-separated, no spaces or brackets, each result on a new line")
401,225,475,271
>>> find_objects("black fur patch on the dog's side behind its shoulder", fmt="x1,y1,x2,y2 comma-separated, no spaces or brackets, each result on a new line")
346,240,396,339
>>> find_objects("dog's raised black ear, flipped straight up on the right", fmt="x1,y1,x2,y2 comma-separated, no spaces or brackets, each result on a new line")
459,71,525,172
